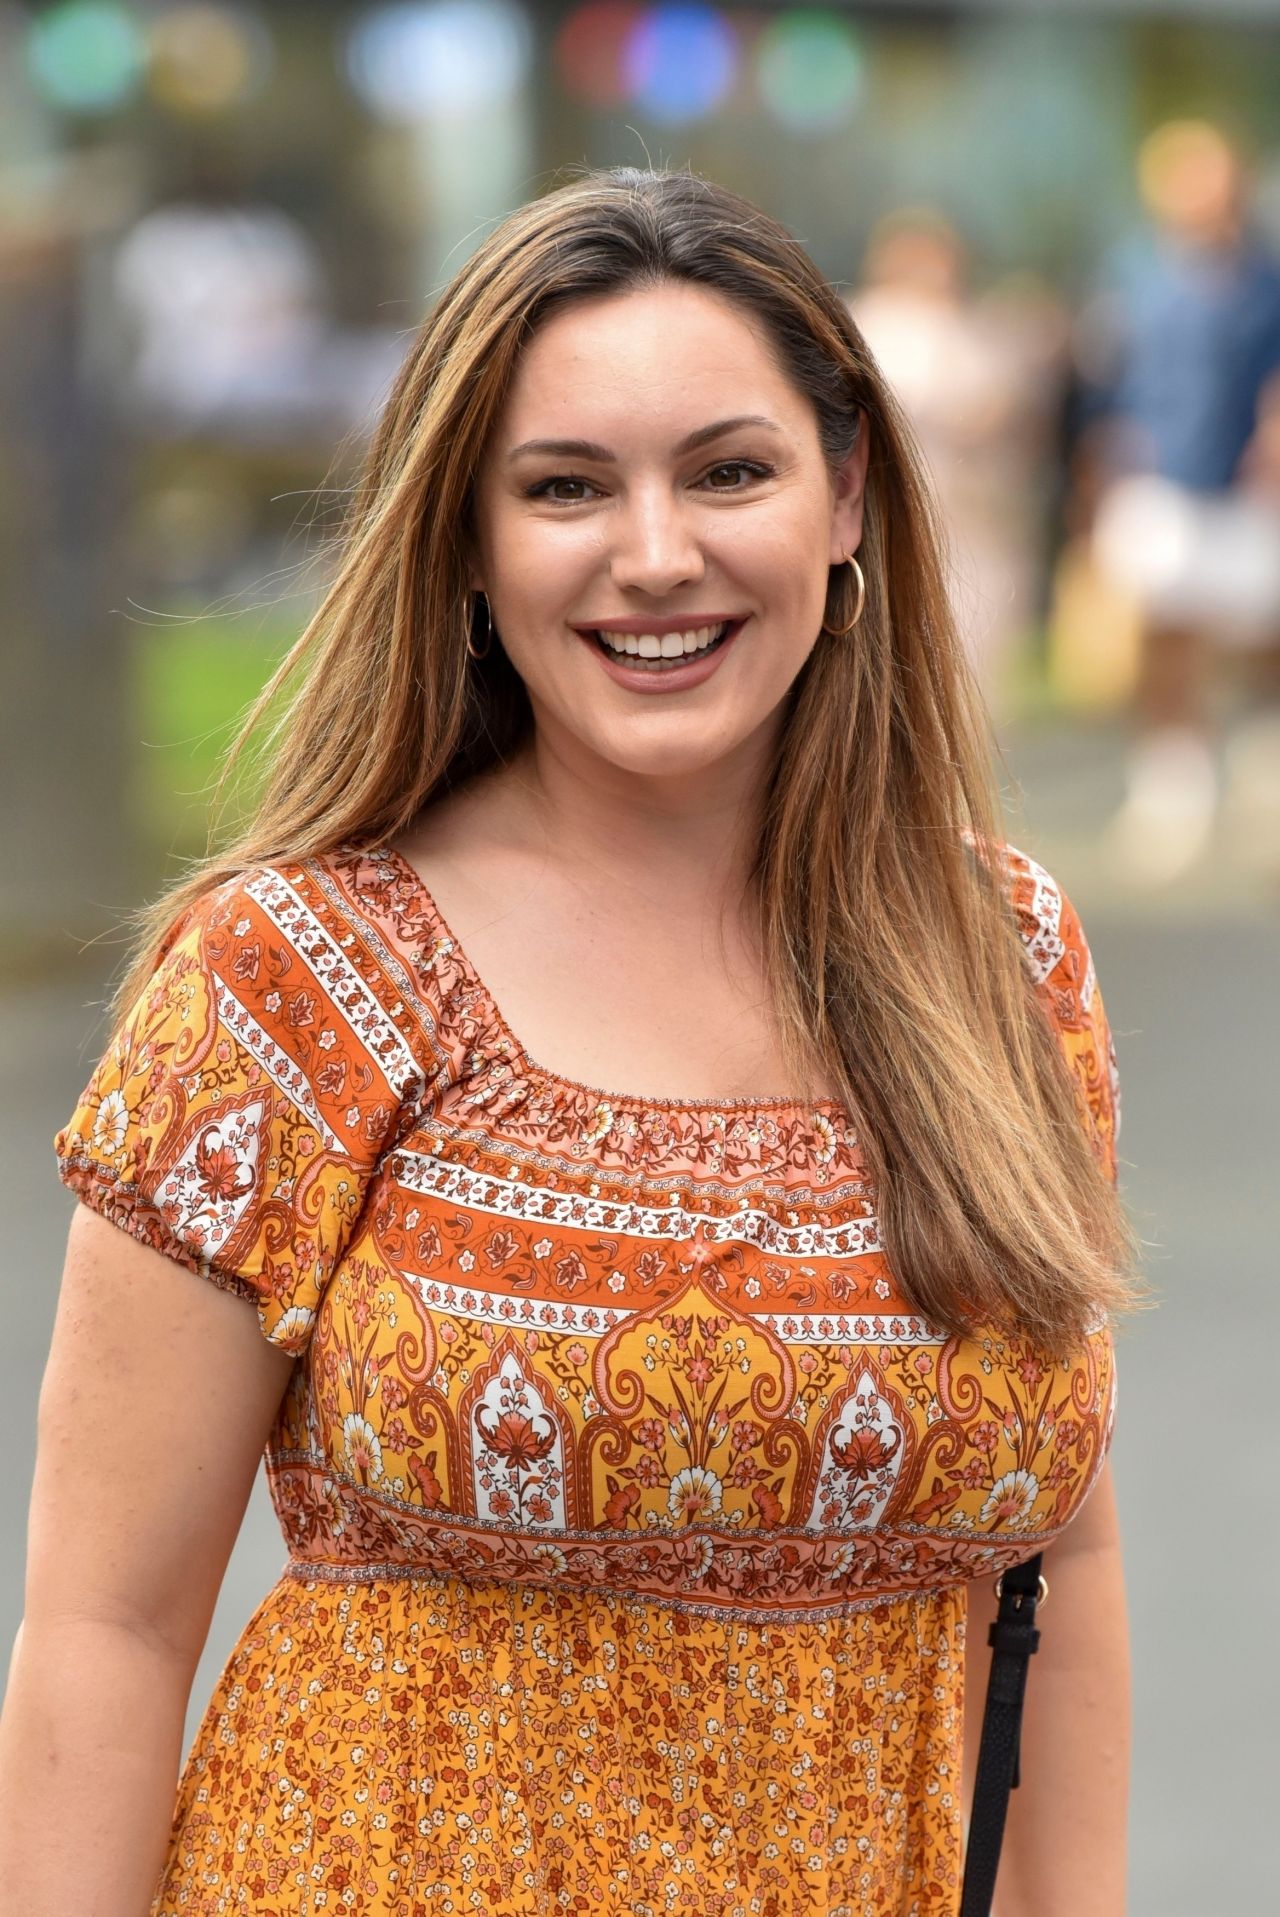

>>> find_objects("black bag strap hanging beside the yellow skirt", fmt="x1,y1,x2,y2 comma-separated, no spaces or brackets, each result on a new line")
960,1553,1048,1917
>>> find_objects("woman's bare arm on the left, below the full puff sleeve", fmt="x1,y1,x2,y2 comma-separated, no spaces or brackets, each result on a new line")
0,1206,293,1917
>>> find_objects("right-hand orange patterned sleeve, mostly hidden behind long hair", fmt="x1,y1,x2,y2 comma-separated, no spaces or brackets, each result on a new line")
1006,845,1121,1183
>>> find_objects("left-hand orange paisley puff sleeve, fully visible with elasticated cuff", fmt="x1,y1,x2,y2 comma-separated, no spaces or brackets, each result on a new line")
54,866,410,1353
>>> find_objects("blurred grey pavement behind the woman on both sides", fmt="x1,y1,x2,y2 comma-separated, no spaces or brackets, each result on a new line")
0,727,1280,1917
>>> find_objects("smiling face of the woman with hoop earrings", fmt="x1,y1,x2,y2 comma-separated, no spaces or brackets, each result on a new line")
471,282,868,776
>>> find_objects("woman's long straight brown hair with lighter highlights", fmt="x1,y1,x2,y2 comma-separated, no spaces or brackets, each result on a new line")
102,169,1134,1351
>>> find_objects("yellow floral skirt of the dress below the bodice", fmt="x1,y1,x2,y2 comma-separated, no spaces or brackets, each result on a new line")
151,1566,966,1917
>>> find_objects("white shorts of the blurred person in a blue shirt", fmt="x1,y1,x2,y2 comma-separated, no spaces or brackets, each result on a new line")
1092,473,1280,646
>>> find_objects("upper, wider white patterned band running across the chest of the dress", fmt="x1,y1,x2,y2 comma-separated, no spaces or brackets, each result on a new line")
389,1150,883,1258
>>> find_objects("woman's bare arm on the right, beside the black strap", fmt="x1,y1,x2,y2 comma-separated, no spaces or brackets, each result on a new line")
964,1465,1129,1917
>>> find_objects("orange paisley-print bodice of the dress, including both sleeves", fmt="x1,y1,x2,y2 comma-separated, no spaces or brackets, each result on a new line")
57,849,1117,1622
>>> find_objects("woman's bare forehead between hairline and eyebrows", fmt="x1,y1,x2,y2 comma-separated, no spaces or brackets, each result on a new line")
498,282,807,439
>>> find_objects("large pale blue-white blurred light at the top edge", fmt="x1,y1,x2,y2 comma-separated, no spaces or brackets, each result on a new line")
347,0,531,121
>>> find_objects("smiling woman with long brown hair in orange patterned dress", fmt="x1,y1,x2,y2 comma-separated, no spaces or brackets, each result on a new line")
0,171,1132,1917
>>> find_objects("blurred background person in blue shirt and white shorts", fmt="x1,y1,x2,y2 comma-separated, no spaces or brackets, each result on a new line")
1079,121,1280,882
